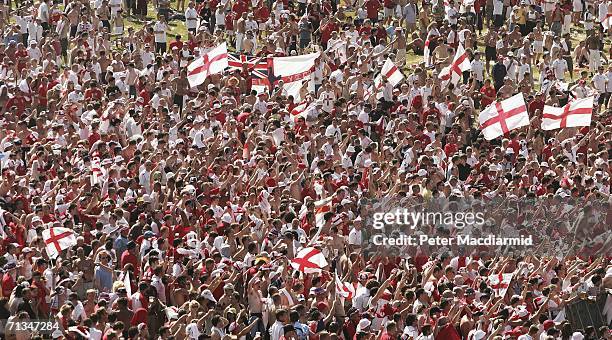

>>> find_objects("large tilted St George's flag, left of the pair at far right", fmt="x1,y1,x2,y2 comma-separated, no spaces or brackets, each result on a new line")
478,93,529,140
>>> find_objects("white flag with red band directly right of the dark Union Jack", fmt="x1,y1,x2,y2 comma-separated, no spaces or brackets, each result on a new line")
268,52,320,100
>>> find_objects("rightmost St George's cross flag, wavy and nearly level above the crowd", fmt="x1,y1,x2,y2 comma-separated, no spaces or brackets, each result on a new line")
542,97,595,130
